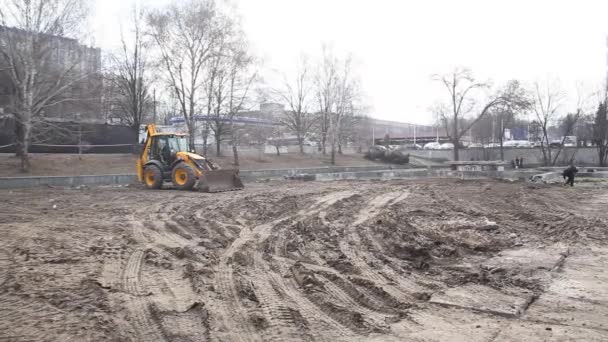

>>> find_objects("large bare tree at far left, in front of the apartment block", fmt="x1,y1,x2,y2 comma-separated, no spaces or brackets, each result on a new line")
0,0,88,172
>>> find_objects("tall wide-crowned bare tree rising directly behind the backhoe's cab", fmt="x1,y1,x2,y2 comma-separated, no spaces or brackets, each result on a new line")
148,0,222,149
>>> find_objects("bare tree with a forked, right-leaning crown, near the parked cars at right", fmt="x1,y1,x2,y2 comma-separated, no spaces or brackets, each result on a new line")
433,68,525,161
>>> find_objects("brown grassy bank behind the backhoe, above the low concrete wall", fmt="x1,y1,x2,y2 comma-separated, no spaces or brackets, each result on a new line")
0,153,382,177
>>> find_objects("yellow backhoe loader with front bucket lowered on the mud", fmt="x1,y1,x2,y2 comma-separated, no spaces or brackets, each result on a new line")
137,125,244,192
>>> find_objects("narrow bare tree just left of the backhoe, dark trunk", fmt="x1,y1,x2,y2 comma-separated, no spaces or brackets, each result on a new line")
111,7,151,140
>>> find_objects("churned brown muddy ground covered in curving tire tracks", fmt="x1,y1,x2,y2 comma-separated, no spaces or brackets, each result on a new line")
0,179,608,342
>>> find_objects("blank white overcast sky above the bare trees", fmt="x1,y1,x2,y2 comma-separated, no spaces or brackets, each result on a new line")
94,0,608,123
